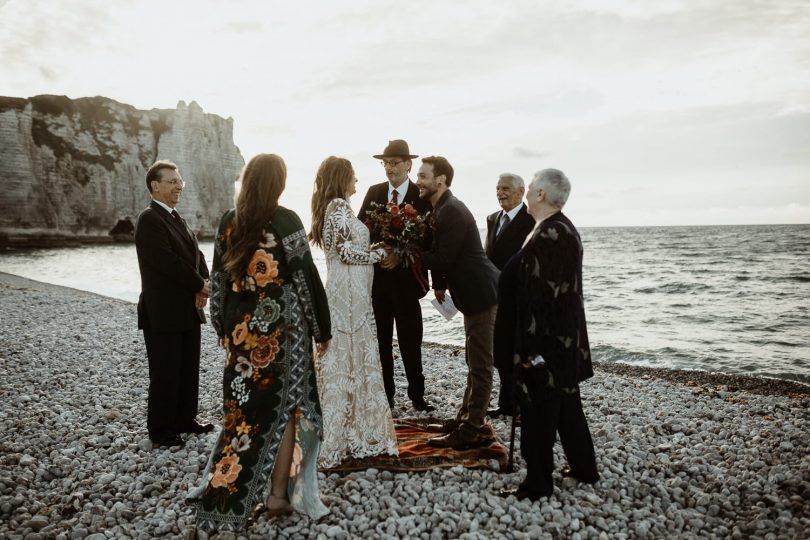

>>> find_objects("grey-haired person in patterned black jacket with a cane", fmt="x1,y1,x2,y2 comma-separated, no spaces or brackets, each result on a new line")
504,169,599,500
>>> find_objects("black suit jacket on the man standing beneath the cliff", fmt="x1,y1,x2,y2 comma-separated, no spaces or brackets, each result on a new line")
135,201,208,332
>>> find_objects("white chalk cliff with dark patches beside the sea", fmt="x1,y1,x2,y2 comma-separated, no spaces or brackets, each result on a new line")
0,95,245,242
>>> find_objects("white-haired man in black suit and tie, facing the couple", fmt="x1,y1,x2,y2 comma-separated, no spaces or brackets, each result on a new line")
486,173,534,418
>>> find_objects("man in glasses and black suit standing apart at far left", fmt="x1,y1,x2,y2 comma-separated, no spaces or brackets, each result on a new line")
135,161,214,446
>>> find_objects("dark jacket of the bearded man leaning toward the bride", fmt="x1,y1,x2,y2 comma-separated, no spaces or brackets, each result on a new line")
422,190,500,315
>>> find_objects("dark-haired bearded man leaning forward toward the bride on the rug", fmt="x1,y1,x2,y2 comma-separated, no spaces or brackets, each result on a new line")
416,156,498,450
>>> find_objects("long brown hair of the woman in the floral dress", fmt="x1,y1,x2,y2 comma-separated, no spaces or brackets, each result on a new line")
223,154,287,281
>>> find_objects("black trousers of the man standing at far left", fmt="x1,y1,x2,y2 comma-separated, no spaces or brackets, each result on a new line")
143,324,200,438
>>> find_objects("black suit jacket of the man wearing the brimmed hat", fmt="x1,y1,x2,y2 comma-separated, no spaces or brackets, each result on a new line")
357,180,430,299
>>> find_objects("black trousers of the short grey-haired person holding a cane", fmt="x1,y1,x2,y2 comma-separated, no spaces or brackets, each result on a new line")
520,368,599,496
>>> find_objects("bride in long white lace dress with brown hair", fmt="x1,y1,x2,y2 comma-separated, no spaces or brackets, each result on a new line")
309,156,398,468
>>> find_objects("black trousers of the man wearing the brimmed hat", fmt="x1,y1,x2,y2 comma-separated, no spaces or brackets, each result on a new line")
371,293,425,401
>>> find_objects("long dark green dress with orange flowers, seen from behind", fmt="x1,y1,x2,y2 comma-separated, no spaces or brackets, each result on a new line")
188,207,331,530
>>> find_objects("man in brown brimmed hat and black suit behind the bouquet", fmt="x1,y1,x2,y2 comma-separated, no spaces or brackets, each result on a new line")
357,139,434,412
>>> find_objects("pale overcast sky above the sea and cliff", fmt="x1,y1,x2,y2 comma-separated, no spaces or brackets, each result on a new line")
0,0,810,226
